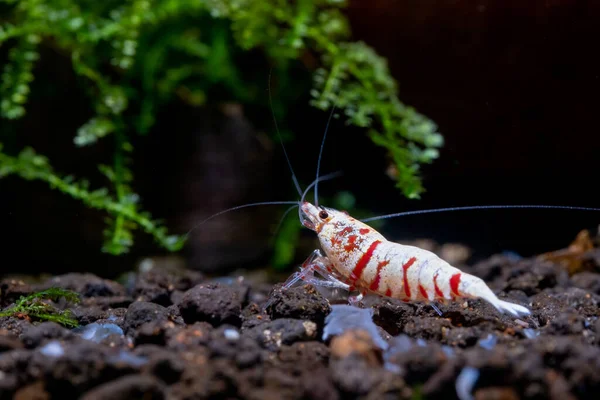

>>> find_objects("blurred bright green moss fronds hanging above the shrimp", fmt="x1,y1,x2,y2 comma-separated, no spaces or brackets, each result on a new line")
0,0,442,254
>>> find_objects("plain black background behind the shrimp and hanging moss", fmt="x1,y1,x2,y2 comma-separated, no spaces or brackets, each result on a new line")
0,0,600,276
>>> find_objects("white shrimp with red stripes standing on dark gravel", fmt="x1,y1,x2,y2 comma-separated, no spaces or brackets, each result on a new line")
284,201,530,316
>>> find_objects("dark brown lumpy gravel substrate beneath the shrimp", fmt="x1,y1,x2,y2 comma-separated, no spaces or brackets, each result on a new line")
0,234,600,400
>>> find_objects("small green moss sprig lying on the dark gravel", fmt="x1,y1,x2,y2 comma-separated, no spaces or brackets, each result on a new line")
0,288,79,328
